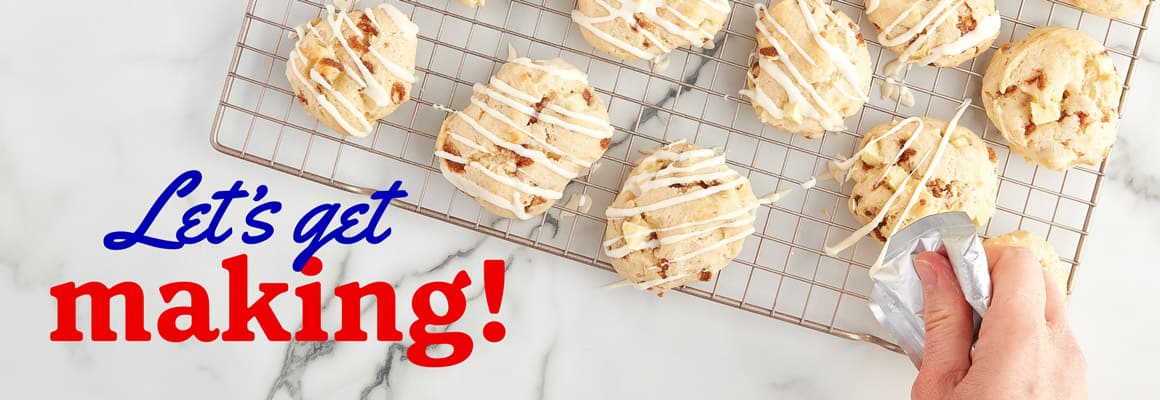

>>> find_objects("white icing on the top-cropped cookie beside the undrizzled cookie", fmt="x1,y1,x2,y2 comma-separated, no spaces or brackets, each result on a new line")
867,0,1002,107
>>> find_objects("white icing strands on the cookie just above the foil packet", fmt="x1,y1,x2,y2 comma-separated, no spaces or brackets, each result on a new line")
824,99,971,268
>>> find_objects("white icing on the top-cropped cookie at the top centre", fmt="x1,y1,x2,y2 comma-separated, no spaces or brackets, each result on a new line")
572,0,730,64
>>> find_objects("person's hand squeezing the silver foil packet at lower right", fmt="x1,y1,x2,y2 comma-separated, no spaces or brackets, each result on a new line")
911,247,1087,400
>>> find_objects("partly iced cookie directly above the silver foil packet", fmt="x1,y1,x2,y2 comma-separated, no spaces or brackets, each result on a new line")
835,111,999,248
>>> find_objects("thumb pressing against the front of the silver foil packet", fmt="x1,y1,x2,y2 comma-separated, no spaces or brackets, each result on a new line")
912,253,974,399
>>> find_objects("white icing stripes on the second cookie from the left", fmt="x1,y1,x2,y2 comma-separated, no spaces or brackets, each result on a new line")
435,50,614,219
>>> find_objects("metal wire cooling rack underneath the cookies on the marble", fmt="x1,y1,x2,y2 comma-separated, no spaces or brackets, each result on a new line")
211,0,1152,351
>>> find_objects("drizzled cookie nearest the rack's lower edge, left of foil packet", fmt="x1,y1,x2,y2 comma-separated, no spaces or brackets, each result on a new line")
603,141,762,293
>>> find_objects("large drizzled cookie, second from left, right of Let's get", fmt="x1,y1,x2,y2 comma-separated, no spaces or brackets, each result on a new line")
435,57,612,219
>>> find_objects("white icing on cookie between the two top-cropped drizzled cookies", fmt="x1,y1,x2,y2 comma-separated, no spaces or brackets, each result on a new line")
741,0,865,130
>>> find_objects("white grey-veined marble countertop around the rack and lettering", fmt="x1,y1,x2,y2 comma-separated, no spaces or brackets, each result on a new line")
0,0,1160,399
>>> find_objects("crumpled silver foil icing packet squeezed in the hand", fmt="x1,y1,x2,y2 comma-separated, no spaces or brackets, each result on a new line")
870,212,991,366
